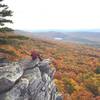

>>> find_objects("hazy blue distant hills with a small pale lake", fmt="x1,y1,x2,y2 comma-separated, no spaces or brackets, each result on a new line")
17,31,100,48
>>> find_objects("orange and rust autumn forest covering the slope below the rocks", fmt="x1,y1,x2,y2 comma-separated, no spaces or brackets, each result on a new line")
0,32,100,100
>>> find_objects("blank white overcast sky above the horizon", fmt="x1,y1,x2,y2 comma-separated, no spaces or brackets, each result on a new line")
5,0,100,30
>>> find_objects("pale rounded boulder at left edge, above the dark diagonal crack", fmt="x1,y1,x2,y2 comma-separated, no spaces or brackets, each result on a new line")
0,63,23,93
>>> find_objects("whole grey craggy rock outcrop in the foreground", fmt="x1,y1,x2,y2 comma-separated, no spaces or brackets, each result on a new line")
0,59,63,100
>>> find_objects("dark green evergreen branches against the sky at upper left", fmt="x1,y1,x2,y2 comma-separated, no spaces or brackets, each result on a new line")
0,0,13,32
